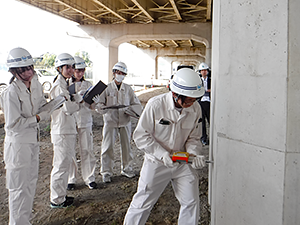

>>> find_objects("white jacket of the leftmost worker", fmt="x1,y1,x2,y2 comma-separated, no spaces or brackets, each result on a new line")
1,75,46,143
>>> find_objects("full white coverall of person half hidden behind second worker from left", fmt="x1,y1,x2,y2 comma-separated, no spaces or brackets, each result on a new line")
68,80,96,185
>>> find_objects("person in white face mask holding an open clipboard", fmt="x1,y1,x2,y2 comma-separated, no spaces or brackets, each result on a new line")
93,62,142,183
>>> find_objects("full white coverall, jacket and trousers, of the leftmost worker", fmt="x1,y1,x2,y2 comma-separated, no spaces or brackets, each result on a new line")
1,75,46,225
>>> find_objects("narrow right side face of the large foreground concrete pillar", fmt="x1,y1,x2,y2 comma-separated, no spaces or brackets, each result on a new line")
283,1,300,225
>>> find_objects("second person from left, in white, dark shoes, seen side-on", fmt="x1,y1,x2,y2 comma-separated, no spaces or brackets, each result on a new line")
50,53,83,209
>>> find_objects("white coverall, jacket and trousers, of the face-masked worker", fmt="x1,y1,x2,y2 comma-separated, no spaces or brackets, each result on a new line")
96,81,142,175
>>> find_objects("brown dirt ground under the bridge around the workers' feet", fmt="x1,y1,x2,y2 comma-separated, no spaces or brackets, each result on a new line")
0,88,210,225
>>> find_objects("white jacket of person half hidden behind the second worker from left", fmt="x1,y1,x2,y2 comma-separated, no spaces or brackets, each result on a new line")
70,80,93,128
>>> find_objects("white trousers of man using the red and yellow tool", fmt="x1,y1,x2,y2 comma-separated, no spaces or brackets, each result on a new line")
124,158,199,225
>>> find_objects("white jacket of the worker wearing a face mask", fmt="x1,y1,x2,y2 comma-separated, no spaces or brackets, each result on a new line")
96,81,142,127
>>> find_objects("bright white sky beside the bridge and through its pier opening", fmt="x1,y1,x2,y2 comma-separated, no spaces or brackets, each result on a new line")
0,0,169,81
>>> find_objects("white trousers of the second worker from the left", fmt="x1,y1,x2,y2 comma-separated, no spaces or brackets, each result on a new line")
50,134,76,204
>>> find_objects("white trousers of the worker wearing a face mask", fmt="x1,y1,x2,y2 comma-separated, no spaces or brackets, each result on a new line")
100,123,133,175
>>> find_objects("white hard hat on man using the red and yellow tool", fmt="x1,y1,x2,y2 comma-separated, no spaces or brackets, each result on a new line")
170,68,205,98
